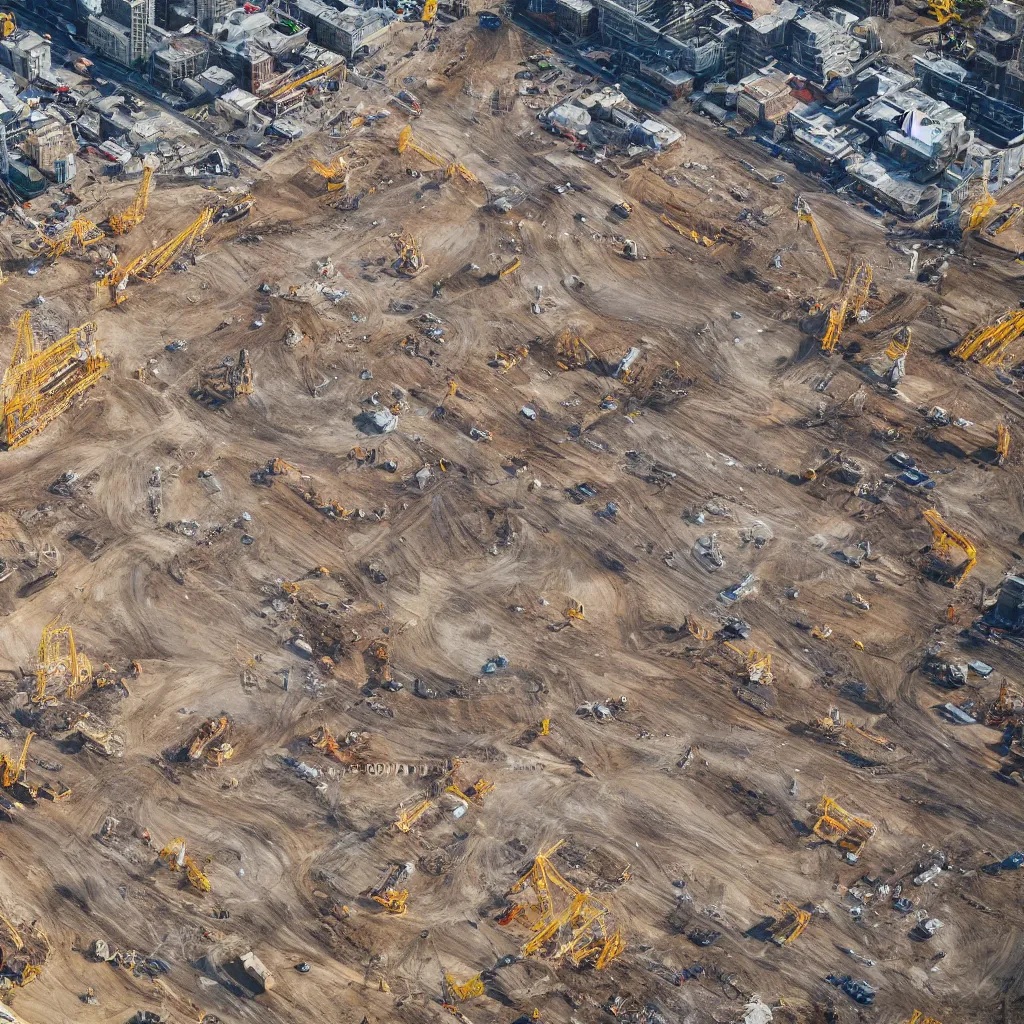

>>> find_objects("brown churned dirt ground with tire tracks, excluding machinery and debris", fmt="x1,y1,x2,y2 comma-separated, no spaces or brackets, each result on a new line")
0,12,1024,1024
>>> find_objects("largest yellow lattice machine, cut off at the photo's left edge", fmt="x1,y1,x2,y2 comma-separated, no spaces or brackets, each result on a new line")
0,311,109,449
